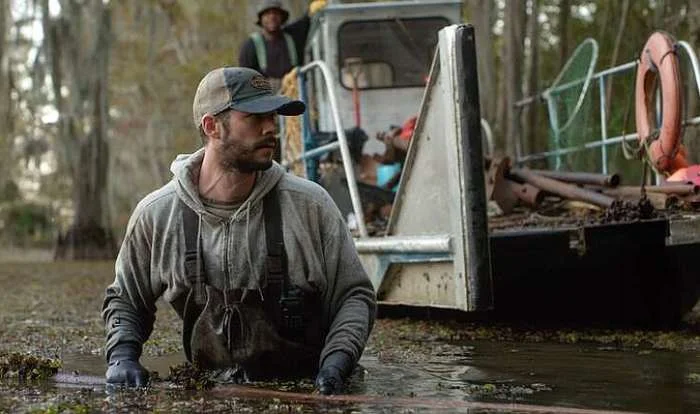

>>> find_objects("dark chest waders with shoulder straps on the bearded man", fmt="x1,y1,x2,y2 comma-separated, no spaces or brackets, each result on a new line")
182,187,324,380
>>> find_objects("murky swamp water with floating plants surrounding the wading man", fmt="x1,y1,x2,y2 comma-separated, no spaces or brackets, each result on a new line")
0,262,700,413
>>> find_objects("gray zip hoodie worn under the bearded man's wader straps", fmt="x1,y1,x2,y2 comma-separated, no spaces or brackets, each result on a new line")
102,149,376,372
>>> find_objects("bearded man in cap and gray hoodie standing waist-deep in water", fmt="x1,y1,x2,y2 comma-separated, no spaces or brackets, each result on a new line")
102,67,376,394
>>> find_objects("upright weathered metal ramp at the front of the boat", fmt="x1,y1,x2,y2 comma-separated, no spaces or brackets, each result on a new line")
356,25,493,311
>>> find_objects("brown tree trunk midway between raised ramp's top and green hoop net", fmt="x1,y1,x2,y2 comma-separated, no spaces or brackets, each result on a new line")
502,1,525,156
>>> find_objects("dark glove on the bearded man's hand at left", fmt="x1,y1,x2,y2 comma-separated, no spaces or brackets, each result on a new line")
105,342,148,387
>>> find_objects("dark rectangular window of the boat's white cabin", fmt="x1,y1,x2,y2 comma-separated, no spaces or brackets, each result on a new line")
338,17,449,89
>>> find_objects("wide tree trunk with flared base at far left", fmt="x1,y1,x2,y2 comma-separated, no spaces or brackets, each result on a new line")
42,0,116,260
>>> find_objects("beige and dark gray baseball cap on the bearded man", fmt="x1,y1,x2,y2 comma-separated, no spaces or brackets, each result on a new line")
192,67,306,127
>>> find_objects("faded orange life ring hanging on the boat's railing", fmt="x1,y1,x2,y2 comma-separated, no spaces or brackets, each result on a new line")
635,32,688,174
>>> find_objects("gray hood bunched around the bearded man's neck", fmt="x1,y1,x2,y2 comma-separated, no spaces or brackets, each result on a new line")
170,148,284,219
